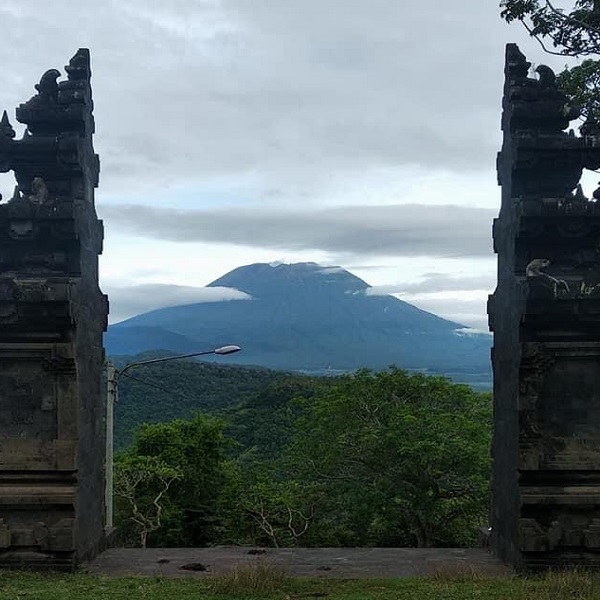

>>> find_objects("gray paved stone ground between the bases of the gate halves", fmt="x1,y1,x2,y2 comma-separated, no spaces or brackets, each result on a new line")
87,546,511,579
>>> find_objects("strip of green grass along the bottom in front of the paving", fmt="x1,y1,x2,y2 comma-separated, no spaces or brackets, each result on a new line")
0,563,600,600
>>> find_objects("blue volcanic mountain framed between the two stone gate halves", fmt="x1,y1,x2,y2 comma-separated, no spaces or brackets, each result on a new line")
106,263,490,385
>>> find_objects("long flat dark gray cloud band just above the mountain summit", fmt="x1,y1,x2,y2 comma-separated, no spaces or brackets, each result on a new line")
101,205,495,262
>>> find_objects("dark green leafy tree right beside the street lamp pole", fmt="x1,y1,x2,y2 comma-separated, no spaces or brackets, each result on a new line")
115,413,231,546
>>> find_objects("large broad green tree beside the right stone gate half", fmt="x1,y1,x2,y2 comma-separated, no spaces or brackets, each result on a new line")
287,368,491,546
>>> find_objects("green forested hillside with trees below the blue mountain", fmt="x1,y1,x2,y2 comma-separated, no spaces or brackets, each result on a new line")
115,363,491,546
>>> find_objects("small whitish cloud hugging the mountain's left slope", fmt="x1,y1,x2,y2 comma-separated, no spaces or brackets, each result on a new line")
106,283,251,323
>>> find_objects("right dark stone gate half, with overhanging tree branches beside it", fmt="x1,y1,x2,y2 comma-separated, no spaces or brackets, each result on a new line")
488,44,600,570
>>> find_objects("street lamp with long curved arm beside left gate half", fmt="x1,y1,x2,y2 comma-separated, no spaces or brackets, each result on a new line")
104,345,241,530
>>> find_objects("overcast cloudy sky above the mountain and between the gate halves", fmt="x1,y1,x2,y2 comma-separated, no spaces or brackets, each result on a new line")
0,0,576,328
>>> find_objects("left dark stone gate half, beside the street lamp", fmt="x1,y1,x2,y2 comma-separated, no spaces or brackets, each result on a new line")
0,49,108,569
